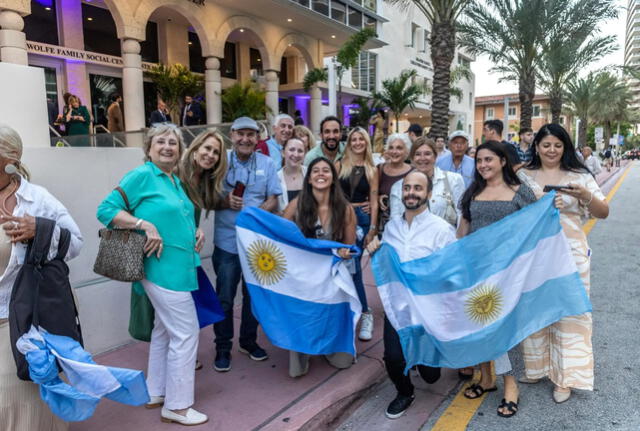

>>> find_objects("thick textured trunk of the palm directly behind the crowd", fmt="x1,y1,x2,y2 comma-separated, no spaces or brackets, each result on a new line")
429,22,456,139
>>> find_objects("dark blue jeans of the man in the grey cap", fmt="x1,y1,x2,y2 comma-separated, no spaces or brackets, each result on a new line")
212,247,258,352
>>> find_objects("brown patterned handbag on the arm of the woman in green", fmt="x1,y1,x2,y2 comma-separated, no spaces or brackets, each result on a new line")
93,187,146,281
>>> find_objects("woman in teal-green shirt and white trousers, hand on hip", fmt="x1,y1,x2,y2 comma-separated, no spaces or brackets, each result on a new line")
97,124,208,425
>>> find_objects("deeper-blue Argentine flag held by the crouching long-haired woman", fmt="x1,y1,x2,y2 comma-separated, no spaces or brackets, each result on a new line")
236,207,362,356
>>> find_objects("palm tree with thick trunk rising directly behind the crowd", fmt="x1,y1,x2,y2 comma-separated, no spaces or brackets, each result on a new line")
387,0,472,138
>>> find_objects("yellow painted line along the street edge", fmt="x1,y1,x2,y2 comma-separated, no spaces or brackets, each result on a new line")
431,162,634,431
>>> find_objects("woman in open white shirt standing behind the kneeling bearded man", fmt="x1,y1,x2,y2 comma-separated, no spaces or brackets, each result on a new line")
389,136,465,226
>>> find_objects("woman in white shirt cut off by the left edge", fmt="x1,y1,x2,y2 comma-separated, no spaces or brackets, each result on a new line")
0,125,82,431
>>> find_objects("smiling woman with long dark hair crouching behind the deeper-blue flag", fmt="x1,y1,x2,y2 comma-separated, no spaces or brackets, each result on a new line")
284,157,356,377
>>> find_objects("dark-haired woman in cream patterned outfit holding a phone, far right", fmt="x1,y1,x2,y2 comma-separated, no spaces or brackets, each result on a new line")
518,124,609,403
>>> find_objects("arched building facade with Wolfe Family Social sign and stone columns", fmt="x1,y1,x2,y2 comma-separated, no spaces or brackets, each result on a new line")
0,0,384,137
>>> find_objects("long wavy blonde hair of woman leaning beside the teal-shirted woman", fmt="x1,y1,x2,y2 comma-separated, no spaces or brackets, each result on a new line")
178,129,227,214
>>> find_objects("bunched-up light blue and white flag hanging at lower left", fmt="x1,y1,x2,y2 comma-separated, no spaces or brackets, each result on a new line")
16,326,149,422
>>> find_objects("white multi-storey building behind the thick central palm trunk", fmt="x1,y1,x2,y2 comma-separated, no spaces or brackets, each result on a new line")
366,2,475,135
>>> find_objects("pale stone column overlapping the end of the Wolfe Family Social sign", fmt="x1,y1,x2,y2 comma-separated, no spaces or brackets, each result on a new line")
122,39,145,131
